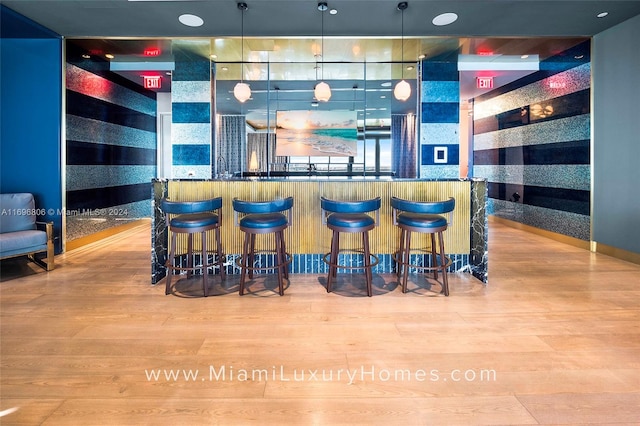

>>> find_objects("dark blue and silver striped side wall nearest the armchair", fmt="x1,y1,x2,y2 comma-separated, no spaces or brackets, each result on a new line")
66,43,157,240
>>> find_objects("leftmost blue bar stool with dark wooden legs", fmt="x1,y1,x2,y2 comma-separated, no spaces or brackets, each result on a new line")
160,197,225,297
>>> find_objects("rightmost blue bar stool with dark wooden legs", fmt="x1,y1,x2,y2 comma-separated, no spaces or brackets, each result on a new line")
391,197,455,296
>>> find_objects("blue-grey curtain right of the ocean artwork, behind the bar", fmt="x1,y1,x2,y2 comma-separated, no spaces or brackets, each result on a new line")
391,114,417,178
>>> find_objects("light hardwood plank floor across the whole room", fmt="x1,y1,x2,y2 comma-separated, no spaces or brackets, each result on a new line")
0,222,640,425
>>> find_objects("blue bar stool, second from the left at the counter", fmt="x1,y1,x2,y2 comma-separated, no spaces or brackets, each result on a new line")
233,197,293,296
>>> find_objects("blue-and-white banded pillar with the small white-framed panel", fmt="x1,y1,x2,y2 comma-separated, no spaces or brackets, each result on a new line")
420,58,460,179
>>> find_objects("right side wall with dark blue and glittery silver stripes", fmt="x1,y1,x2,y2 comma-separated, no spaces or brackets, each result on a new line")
473,43,591,241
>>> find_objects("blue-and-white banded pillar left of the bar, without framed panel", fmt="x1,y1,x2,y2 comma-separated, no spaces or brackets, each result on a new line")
171,40,212,179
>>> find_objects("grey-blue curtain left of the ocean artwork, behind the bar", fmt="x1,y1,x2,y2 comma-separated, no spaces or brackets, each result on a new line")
214,115,248,174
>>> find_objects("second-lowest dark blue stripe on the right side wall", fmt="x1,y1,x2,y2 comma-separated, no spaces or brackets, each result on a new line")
473,139,591,166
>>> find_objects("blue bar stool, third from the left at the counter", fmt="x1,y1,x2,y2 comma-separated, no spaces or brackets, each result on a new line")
320,197,381,297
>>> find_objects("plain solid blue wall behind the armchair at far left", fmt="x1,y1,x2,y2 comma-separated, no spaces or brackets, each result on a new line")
0,5,63,253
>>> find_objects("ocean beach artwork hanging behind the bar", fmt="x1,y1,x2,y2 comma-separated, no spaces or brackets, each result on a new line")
276,111,358,157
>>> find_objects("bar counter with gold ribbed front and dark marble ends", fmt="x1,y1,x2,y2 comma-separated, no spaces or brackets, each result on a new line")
151,177,488,284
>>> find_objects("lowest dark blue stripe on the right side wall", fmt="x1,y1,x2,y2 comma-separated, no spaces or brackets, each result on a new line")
487,182,591,216
